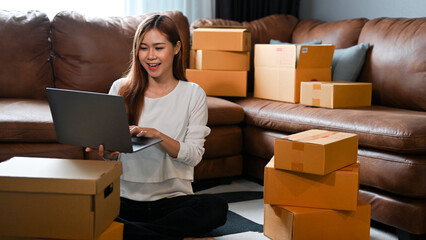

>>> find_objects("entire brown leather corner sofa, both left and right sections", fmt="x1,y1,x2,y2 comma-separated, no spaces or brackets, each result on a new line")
0,8,426,236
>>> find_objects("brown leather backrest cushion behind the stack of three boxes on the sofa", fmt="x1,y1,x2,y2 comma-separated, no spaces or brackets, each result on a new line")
190,14,299,92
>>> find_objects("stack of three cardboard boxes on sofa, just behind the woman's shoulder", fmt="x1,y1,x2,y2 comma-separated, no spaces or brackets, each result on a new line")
186,28,251,97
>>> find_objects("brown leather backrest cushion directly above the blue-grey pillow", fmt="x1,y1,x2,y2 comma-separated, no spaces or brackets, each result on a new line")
291,18,368,48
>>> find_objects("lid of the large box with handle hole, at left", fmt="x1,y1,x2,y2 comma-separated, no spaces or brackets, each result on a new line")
0,157,122,194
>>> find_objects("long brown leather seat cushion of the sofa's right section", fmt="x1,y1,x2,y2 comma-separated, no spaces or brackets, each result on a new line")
237,98,426,154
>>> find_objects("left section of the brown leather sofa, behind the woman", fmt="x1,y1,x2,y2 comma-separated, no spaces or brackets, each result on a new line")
0,11,244,179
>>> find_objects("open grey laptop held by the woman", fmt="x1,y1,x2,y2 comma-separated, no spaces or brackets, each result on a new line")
46,88,162,153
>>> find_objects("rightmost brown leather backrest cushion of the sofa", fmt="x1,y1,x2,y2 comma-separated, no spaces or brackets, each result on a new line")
359,18,426,111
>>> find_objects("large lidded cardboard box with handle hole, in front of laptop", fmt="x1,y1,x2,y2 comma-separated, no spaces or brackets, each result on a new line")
0,157,122,239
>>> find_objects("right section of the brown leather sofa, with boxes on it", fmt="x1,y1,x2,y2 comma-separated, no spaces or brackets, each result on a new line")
191,15,426,239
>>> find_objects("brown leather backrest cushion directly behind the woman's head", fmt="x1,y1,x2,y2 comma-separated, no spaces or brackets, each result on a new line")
52,11,189,92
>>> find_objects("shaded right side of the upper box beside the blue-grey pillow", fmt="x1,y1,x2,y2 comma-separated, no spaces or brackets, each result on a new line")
297,45,334,69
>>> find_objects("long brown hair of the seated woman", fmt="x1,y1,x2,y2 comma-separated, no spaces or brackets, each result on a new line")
118,15,187,125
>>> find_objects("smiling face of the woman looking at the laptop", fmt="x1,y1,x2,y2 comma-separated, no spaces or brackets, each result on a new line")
138,29,180,79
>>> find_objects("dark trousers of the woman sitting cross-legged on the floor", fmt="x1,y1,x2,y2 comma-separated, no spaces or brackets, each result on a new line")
116,194,228,240
